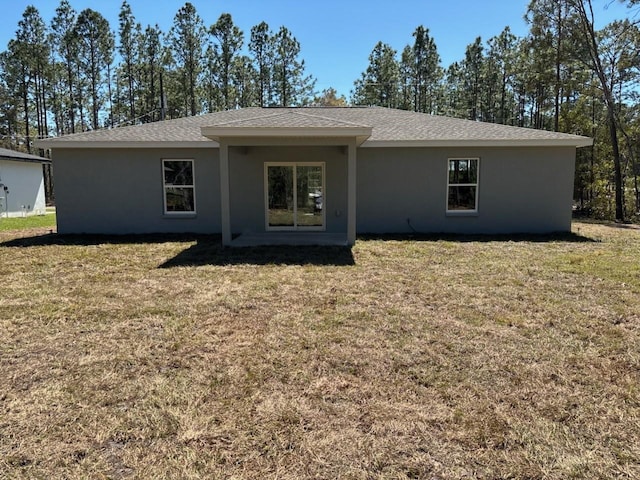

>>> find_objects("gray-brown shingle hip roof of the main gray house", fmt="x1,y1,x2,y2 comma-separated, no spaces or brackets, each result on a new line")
39,107,591,148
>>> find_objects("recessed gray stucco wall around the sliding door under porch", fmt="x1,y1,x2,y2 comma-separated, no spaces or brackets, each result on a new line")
229,146,347,234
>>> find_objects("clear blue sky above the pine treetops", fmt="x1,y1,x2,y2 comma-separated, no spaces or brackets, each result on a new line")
0,0,628,97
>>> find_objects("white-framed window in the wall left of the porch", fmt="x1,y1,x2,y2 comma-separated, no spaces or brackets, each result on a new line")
162,160,196,214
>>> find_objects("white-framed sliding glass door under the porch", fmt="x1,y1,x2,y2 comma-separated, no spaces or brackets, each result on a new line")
265,163,325,230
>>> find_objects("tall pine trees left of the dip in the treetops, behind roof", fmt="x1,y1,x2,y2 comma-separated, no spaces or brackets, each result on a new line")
0,0,315,149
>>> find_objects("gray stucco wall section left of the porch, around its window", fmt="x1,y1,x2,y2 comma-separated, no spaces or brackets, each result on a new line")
53,149,220,234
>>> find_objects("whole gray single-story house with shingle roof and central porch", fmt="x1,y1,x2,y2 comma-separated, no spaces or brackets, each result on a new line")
38,107,592,245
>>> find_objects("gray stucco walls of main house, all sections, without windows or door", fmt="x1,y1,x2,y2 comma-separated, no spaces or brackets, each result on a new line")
53,145,575,234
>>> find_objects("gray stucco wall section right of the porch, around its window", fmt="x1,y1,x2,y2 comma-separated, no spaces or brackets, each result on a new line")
357,147,575,233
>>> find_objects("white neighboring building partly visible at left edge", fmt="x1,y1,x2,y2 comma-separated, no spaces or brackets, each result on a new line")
0,148,51,217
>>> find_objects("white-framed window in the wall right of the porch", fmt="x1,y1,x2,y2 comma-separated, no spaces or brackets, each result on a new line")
447,158,480,213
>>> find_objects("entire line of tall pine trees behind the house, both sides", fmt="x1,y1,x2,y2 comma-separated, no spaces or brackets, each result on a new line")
0,0,640,221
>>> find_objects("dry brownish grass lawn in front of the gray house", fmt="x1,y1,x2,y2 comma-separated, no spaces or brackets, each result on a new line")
0,223,640,479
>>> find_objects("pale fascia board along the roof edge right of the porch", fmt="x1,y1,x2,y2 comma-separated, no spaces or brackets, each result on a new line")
362,137,593,148
